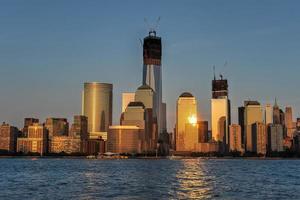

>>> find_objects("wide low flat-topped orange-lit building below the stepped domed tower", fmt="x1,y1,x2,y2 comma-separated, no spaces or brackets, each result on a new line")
107,125,144,154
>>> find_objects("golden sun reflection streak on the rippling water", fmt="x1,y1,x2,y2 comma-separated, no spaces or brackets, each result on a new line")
176,159,213,199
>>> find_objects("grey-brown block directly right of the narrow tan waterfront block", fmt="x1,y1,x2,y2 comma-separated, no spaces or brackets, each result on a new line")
268,124,283,152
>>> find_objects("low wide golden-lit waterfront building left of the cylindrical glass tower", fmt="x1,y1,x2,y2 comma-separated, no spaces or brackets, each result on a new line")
49,136,83,154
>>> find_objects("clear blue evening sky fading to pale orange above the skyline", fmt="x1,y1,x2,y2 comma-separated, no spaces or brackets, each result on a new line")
0,0,300,130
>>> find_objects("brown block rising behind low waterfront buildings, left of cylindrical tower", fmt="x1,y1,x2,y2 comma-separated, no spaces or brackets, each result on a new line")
45,118,69,139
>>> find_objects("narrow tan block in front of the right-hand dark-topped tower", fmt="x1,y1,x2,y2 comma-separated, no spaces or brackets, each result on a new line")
252,122,267,155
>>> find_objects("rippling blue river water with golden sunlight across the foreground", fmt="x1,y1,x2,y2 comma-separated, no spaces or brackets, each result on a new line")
0,159,300,200
